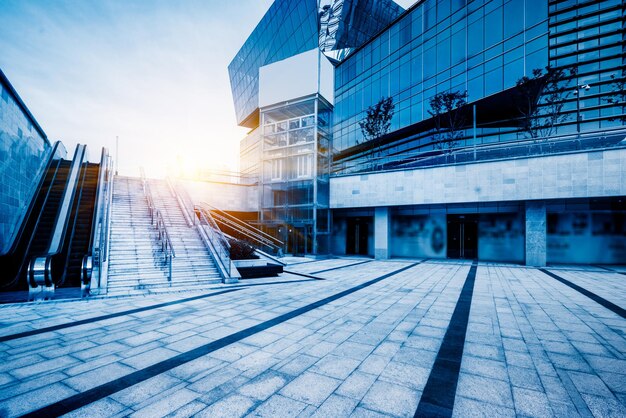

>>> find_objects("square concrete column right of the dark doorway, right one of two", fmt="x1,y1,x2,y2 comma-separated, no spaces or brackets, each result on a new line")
526,201,548,267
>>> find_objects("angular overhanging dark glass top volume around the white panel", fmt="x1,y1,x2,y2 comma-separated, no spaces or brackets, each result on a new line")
228,0,403,128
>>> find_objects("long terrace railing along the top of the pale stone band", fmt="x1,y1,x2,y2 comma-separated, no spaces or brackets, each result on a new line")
333,128,626,176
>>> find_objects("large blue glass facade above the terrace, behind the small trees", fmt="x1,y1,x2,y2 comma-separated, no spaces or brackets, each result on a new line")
333,0,626,173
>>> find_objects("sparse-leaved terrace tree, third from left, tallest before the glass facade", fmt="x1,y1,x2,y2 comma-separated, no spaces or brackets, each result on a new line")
516,67,577,139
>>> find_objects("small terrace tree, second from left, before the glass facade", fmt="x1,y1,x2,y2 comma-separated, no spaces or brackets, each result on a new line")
428,91,467,151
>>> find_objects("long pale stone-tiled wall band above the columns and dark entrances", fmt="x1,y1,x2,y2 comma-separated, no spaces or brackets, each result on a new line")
330,148,626,209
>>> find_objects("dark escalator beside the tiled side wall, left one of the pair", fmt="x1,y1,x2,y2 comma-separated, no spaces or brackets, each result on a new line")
0,142,71,300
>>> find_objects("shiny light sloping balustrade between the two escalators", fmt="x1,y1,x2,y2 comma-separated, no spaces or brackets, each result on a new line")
47,144,87,256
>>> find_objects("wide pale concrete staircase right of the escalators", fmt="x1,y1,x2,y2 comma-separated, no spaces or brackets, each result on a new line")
107,176,220,296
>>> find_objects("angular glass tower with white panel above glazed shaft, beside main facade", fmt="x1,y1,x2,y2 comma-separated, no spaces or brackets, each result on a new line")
229,0,403,254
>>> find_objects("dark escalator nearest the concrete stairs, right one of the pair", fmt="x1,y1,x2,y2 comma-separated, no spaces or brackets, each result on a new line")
51,162,100,288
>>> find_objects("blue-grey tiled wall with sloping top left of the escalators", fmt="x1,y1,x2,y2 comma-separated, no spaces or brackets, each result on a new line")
0,84,51,254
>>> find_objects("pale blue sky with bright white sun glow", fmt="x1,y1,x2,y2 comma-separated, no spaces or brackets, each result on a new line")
0,0,412,176
